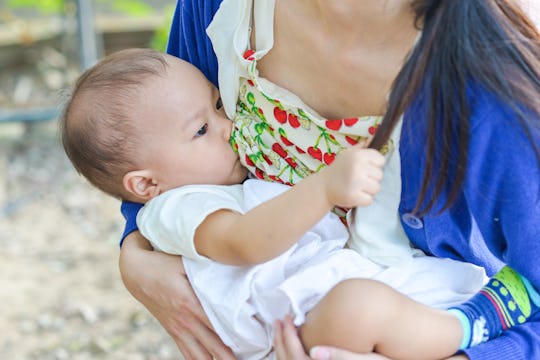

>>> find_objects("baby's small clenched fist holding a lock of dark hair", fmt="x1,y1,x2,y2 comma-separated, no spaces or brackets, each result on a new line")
323,144,385,208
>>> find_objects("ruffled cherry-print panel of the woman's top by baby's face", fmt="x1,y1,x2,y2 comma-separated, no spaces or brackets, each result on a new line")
231,50,381,185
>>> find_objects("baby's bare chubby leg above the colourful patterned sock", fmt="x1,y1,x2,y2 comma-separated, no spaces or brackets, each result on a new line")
299,279,462,360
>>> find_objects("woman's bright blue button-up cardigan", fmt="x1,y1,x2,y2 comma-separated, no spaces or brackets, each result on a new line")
122,0,540,360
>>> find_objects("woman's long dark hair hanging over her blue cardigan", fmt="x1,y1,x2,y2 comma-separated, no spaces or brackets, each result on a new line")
370,0,540,213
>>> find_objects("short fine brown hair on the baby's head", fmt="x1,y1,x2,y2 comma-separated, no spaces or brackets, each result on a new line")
60,49,167,199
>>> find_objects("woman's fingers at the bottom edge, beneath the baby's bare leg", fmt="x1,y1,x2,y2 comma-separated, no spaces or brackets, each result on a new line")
274,316,469,360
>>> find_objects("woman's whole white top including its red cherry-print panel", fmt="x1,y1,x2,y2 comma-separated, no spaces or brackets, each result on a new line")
207,0,414,265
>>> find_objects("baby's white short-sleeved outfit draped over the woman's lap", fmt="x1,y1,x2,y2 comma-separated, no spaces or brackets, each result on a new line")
137,180,484,359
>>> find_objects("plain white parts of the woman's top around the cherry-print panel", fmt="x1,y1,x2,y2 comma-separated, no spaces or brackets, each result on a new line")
207,0,414,266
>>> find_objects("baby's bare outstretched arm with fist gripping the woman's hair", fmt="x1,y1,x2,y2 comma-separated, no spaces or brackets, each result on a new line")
195,146,384,265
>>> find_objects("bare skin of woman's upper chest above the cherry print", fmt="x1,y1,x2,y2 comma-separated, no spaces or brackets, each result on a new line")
251,3,417,118
